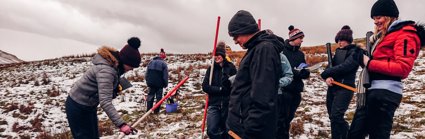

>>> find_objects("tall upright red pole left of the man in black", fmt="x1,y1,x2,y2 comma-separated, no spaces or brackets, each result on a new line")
201,16,220,139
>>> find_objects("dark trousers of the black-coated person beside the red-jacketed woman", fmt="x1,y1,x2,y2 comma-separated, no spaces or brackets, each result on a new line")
326,86,353,139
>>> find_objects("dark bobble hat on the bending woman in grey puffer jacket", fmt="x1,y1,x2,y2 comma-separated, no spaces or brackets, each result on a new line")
119,37,141,68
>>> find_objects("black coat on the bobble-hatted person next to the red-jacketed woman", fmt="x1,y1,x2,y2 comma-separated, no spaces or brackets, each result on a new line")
320,44,363,87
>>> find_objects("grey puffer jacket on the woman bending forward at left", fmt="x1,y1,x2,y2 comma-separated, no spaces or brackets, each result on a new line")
69,46,125,127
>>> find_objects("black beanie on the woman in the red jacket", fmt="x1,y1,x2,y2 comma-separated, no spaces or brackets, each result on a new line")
370,0,399,18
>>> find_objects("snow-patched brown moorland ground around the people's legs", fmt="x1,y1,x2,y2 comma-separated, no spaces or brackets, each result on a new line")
0,52,425,138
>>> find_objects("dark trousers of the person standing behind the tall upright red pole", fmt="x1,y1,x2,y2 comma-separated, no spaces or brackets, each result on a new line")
207,106,228,139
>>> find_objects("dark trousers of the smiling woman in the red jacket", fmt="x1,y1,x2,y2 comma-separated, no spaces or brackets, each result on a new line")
348,89,402,139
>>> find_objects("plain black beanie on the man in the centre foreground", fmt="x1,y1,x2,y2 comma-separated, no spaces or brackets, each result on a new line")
228,10,260,37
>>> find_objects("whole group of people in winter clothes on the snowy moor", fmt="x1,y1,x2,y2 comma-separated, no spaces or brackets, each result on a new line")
65,0,425,139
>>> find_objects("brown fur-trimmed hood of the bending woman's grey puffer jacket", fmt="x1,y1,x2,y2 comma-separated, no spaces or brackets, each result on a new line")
92,46,119,68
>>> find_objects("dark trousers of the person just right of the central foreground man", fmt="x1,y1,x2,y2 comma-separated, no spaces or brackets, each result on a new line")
276,91,301,139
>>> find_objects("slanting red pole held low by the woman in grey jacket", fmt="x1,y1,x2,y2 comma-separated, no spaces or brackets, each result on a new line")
118,76,189,139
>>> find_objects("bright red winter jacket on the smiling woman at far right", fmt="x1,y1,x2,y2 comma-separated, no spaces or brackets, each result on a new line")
368,21,421,79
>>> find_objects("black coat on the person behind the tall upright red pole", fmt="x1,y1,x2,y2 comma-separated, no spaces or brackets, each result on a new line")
202,60,236,107
